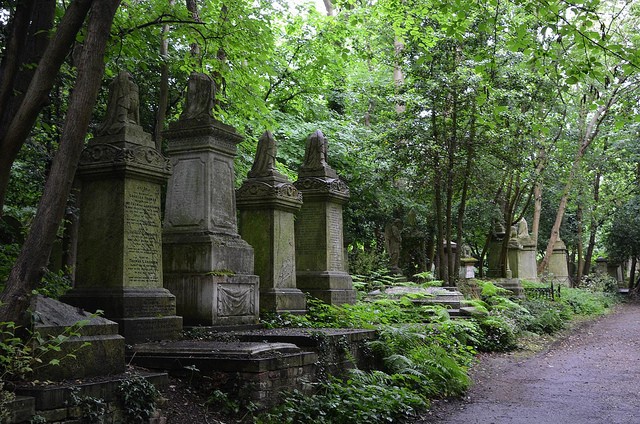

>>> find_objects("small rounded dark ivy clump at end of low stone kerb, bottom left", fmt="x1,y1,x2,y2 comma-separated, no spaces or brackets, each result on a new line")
116,376,160,424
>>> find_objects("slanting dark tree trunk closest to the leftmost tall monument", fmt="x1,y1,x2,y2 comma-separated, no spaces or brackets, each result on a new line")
0,0,120,321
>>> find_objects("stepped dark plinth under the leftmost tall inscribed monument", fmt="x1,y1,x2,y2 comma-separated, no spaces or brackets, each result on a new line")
63,288,182,344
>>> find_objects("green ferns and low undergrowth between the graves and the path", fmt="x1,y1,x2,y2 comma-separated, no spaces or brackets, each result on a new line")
255,274,617,424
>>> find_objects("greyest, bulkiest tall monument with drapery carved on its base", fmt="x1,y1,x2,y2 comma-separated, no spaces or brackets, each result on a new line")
163,73,259,325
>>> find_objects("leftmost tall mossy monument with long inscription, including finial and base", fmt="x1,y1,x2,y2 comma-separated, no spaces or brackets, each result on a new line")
63,72,182,343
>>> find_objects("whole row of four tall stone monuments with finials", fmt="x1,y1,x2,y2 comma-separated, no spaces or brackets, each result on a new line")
63,72,355,344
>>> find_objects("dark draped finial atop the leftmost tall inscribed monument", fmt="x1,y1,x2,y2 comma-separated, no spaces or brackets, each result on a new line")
98,71,140,135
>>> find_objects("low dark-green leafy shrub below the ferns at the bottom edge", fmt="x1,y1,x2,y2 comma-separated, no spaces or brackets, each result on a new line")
256,370,428,424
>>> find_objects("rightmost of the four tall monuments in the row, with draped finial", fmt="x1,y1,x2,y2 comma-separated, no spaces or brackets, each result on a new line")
294,131,356,305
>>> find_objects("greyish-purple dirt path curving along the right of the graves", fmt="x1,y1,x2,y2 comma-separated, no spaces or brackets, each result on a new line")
418,304,640,424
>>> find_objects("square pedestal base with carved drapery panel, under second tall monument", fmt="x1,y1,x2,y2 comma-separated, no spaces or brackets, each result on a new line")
164,273,260,325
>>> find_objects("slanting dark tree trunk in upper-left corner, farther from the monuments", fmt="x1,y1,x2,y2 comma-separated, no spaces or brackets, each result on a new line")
0,0,92,219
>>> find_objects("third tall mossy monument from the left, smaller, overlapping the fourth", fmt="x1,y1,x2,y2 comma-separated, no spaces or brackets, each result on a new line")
236,132,306,313
